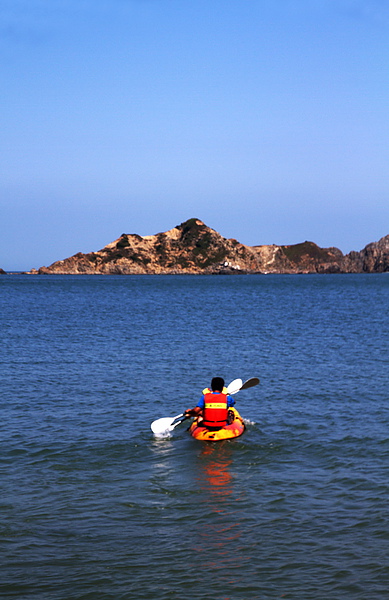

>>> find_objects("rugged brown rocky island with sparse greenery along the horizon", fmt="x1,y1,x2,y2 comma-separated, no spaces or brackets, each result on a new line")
30,219,389,275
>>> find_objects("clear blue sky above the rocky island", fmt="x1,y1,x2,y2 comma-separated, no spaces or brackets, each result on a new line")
0,0,389,270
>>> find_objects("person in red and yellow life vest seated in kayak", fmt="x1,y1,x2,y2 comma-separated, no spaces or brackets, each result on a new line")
184,377,235,429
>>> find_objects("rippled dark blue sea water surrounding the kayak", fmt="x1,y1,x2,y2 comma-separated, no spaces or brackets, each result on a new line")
0,274,389,600
